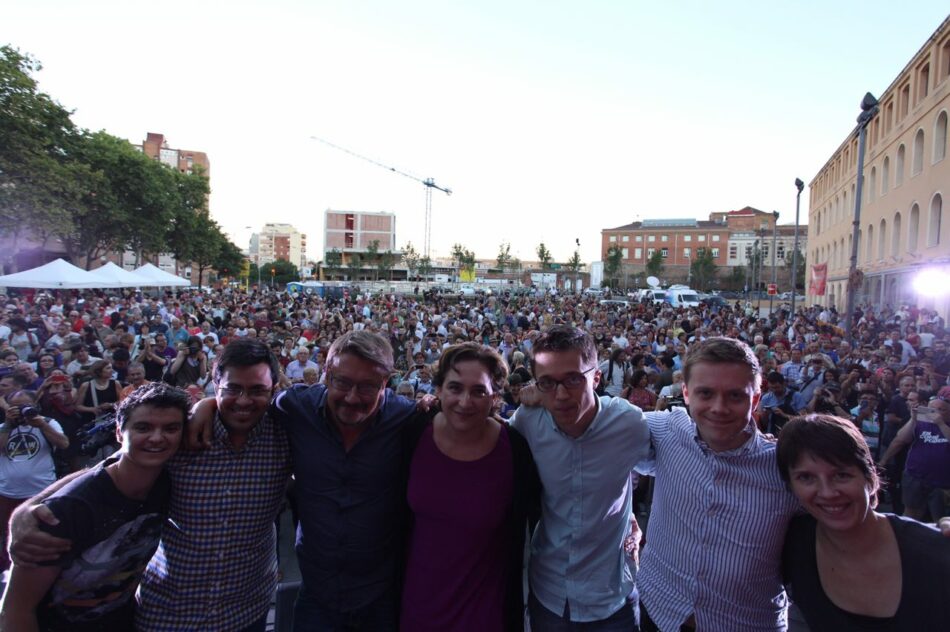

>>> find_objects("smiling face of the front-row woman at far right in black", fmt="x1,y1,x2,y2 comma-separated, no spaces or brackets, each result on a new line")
789,452,875,531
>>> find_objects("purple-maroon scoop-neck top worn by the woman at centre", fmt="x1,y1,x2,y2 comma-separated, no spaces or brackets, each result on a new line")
399,426,514,632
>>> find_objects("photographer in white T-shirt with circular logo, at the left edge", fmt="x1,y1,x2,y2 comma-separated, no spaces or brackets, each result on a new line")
0,391,69,571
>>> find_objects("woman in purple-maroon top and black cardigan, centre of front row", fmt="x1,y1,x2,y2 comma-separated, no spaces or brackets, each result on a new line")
400,343,540,632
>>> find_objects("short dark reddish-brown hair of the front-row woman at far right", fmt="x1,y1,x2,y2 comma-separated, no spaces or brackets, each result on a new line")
775,414,881,507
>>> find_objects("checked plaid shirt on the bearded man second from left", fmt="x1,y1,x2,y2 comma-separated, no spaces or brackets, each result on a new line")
136,415,292,632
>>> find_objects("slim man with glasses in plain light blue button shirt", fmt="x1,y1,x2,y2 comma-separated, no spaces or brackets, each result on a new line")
511,325,650,631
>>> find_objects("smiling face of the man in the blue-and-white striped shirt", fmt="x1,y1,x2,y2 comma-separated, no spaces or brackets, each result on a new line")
683,362,761,452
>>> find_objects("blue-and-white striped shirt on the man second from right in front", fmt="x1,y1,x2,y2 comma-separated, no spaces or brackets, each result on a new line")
638,408,799,632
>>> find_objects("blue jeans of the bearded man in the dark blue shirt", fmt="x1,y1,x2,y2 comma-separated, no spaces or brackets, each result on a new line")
294,589,399,632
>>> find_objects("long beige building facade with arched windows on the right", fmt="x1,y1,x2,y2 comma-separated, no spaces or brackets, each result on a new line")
806,18,950,318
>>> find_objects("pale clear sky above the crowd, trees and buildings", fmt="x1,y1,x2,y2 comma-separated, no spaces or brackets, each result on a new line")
0,0,947,262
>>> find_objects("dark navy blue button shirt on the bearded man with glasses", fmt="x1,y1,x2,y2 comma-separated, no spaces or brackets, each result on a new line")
272,384,415,612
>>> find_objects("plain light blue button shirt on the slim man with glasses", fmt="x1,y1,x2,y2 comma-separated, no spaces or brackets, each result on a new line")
511,397,650,622
